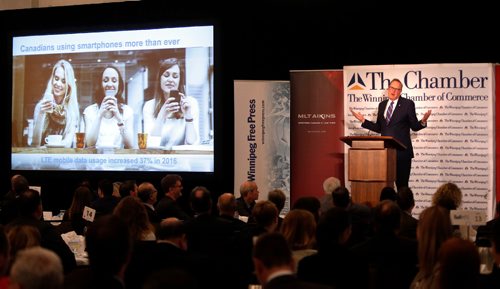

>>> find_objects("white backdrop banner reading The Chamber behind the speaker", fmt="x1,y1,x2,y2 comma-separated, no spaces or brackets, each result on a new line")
344,63,495,219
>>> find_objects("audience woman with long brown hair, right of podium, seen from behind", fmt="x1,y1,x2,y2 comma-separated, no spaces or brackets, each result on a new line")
410,206,453,289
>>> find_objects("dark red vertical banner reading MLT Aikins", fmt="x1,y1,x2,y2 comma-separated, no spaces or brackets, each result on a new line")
290,70,344,204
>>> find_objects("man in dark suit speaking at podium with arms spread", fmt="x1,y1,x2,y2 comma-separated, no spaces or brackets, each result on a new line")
351,78,432,188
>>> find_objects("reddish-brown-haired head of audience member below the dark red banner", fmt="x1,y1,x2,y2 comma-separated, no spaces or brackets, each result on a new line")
280,209,317,268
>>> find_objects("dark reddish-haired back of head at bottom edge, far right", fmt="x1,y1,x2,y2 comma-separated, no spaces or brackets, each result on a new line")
438,237,480,289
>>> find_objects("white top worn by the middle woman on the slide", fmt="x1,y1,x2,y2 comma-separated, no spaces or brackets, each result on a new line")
83,103,134,148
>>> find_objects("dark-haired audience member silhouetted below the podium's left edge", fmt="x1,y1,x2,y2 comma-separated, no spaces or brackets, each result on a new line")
297,207,368,289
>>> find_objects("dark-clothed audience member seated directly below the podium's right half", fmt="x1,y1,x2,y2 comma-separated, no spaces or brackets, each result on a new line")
352,200,418,289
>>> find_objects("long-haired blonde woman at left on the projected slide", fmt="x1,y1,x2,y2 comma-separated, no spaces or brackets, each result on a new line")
33,60,80,147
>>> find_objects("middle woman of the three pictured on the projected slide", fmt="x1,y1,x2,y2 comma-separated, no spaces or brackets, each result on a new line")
83,66,134,148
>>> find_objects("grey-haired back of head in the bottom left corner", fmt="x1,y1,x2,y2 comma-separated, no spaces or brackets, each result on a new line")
10,247,64,289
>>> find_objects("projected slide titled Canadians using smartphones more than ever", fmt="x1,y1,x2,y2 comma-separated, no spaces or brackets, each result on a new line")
11,26,215,172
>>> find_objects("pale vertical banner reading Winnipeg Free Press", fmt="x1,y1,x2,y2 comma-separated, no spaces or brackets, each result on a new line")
234,80,290,210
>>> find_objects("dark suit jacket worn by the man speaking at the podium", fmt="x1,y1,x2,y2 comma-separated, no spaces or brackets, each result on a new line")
361,97,425,158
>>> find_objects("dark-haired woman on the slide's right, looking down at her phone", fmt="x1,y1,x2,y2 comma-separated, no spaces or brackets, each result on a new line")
142,58,199,149
